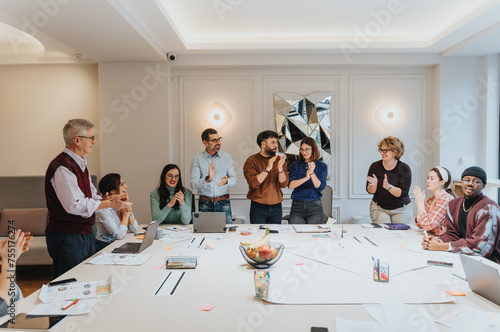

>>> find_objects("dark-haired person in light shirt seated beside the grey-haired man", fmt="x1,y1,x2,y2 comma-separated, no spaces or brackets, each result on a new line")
96,173,138,252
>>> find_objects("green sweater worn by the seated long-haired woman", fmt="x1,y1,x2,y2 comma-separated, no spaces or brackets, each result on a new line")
150,188,193,225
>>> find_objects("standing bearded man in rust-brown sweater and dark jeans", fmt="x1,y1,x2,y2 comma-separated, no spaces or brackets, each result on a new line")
243,130,288,224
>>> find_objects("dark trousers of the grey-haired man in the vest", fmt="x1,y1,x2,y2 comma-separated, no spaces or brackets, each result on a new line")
45,232,95,279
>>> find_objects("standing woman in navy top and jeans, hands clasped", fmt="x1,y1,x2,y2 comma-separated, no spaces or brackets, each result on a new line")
288,137,327,224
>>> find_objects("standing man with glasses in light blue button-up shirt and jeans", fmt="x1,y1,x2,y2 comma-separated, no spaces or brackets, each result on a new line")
191,128,238,224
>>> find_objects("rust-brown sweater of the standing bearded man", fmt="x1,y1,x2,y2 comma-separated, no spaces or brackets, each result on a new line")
243,153,288,205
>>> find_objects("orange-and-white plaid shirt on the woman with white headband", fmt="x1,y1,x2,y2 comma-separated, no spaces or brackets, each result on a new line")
416,193,453,236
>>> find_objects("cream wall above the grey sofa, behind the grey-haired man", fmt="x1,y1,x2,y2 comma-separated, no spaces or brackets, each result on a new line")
0,64,99,176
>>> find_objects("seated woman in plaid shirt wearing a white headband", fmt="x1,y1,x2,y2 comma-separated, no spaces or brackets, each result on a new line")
413,166,455,236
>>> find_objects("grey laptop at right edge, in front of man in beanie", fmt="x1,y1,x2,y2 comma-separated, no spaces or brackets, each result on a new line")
460,255,500,305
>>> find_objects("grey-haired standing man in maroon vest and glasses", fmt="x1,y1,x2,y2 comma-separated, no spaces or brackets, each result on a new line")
45,119,128,279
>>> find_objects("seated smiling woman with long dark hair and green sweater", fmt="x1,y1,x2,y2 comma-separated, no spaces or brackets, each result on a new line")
150,164,193,225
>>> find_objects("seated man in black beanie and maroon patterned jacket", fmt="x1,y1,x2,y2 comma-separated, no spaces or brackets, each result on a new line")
422,166,500,263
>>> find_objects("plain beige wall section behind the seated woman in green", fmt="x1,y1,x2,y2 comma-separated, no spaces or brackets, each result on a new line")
99,63,172,223
